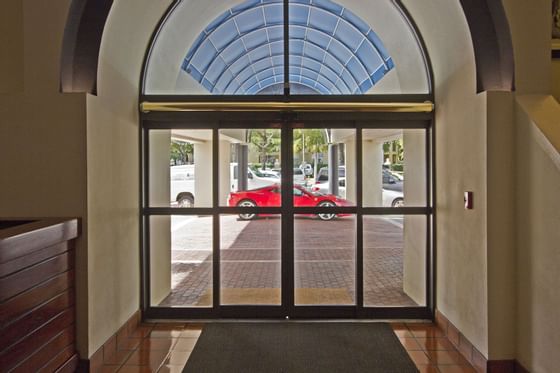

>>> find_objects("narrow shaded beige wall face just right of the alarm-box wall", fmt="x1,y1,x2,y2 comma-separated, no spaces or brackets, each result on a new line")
486,92,516,360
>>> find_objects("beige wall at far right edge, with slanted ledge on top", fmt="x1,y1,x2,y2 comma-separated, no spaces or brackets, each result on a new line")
516,97,560,373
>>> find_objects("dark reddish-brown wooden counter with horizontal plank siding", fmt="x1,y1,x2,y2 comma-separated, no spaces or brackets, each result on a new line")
0,219,79,372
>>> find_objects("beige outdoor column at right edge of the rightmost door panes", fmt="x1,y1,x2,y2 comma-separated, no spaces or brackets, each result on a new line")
403,130,426,305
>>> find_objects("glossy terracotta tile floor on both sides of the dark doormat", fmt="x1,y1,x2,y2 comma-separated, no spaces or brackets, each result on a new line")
98,323,476,373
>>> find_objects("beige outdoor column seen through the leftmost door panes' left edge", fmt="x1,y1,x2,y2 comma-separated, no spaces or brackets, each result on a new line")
149,130,171,305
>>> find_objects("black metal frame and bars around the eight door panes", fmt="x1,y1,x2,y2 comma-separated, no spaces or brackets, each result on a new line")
140,108,435,319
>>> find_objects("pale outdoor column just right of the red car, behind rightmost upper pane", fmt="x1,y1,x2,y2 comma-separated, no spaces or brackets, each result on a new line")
360,140,383,207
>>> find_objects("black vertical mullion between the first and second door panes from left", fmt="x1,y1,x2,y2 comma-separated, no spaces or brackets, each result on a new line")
212,127,221,314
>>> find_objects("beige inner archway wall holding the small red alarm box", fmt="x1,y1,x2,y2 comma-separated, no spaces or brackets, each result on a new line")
403,0,488,355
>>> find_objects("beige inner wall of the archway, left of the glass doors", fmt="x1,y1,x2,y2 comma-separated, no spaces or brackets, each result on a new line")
87,0,169,355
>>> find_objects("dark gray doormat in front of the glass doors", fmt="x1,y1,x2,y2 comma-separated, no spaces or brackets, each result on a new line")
183,322,418,373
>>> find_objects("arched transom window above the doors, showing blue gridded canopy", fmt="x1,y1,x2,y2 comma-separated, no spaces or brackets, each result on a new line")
144,0,430,95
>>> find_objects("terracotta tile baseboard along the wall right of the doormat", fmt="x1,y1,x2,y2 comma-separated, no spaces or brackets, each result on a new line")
435,310,530,373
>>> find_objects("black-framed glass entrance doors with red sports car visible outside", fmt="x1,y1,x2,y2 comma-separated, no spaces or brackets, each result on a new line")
143,118,431,318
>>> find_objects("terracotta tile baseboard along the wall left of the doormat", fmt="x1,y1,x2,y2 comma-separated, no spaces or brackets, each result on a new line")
77,310,142,373
